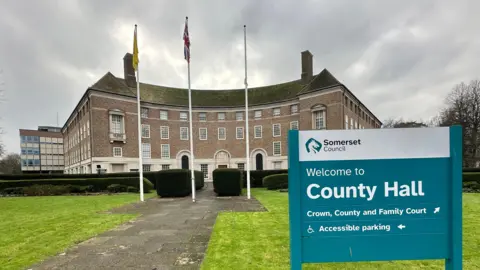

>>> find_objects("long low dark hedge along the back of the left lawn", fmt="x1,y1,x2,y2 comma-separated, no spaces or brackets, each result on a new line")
0,177,153,193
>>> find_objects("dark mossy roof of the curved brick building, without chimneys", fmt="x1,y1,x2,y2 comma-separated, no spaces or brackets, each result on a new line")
91,69,341,107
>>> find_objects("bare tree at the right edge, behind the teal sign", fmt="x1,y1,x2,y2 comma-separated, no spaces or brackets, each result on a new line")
438,80,480,167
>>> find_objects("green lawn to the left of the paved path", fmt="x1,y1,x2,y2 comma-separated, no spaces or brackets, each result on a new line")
0,192,156,270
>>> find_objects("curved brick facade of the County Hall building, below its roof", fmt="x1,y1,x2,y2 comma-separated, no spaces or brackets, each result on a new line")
62,50,381,177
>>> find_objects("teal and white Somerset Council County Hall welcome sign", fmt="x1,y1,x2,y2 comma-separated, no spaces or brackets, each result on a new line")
288,127,462,270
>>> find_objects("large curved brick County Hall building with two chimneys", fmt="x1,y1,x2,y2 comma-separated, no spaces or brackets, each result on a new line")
62,51,382,179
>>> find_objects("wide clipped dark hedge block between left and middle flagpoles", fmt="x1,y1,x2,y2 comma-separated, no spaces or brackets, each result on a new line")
155,169,205,197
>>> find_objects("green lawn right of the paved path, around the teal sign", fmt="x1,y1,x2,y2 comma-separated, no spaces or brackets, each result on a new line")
202,189,480,270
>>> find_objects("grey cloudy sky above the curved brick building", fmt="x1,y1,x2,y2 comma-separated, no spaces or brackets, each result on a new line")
0,0,480,152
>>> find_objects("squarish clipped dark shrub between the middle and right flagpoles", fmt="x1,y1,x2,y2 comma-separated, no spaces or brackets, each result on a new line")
212,168,243,196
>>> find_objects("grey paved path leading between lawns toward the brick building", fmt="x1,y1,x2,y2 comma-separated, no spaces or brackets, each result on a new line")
29,186,265,270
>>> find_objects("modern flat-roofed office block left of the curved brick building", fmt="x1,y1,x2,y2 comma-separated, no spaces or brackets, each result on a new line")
20,126,64,173
